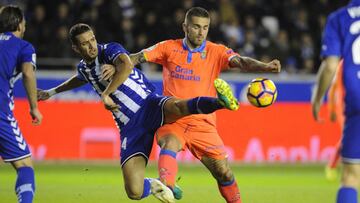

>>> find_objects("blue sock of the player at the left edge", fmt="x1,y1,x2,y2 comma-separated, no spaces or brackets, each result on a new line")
15,167,35,203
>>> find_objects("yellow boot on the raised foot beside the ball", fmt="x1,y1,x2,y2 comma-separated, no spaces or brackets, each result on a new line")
214,78,239,111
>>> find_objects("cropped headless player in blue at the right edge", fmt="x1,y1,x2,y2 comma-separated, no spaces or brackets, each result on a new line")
312,0,360,203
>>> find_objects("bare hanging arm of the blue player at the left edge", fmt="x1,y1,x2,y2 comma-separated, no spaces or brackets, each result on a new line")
21,62,42,125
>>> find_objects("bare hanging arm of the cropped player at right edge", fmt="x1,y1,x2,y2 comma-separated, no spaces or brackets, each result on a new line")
311,56,340,121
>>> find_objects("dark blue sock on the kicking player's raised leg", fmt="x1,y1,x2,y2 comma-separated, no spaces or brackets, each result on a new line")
187,97,224,114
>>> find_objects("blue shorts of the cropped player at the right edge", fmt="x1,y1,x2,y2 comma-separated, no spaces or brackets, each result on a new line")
341,115,360,164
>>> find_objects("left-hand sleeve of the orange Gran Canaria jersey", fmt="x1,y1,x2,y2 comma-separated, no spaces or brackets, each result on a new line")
143,41,169,64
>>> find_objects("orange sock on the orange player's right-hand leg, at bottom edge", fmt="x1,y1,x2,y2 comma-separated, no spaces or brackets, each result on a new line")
218,179,241,203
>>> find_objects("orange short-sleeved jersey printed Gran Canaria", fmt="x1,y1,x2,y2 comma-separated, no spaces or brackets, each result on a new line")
143,39,238,127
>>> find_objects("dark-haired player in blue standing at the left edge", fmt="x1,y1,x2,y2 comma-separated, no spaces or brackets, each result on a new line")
0,6,42,203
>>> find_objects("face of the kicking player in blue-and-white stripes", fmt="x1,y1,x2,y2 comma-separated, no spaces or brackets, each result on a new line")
74,31,98,61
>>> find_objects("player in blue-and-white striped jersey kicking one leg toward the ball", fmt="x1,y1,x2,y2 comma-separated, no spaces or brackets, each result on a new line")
38,24,238,202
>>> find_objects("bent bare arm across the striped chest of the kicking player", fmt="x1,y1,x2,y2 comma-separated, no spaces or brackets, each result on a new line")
101,54,134,110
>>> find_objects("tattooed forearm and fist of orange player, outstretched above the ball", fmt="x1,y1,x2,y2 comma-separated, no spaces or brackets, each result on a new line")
229,56,281,73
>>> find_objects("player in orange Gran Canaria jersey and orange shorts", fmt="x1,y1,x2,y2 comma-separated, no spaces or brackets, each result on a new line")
103,7,281,203
